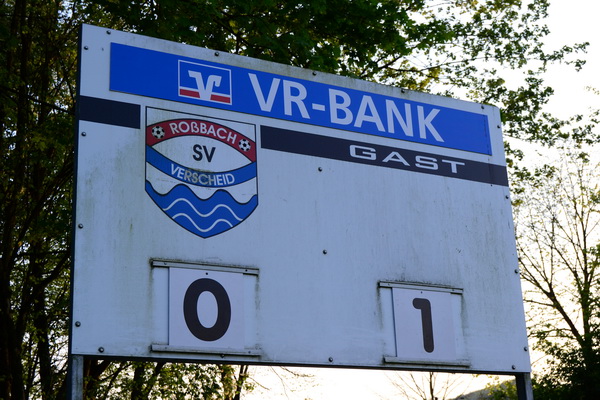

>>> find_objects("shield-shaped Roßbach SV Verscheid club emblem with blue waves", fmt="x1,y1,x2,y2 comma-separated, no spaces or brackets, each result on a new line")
146,109,258,238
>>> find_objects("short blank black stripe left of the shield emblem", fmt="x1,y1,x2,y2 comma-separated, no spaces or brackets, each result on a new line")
77,96,141,129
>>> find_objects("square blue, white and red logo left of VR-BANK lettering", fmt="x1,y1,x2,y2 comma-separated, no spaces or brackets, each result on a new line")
179,60,231,104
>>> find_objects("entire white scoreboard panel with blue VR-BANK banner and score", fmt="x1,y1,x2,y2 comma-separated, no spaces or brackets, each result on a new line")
71,25,530,374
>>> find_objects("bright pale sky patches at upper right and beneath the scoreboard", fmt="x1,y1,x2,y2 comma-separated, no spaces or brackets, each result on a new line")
243,0,600,400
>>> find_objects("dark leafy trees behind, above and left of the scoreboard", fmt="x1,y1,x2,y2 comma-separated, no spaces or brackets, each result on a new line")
0,0,582,399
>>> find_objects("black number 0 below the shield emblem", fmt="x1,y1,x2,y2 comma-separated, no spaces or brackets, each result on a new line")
183,278,231,342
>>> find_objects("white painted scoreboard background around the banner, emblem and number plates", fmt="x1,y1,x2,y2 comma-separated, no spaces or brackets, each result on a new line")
73,26,530,373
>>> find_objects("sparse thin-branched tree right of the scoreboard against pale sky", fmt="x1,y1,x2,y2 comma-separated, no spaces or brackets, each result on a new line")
515,141,600,399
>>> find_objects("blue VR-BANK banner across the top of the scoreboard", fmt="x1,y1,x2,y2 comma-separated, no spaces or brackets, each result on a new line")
110,43,491,154
